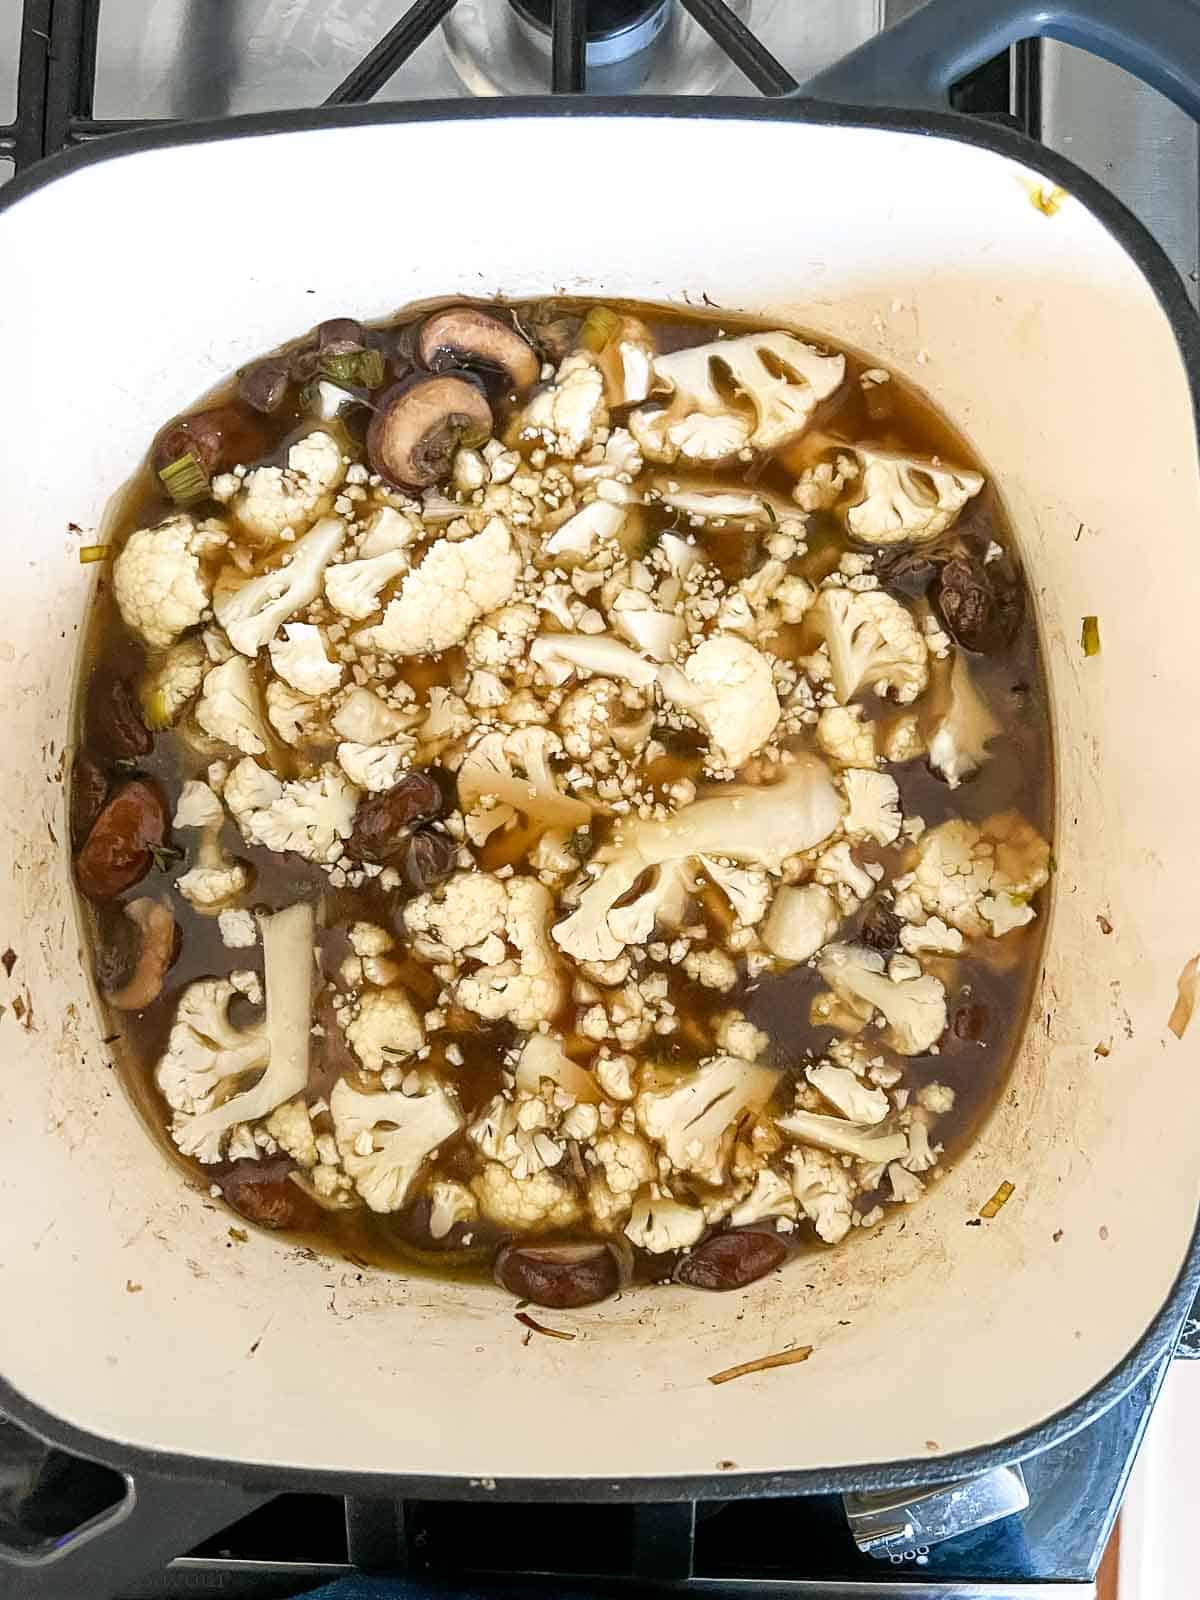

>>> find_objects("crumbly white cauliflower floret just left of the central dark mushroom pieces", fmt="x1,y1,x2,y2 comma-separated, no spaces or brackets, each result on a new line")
226,757,358,862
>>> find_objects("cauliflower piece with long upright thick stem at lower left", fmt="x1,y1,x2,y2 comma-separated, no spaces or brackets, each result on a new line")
154,904,315,1163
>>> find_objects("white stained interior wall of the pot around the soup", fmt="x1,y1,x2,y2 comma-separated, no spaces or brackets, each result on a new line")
0,117,1200,1478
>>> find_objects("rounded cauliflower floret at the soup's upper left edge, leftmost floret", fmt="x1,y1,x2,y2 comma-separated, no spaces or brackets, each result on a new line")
112,514,213,650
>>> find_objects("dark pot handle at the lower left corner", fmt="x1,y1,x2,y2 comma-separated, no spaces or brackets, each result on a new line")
0,1472,274,1600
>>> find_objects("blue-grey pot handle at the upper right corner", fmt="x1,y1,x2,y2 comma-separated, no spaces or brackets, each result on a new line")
795,0,1200,122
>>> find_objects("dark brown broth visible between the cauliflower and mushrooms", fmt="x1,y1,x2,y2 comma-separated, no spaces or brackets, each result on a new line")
72,301,1053,1277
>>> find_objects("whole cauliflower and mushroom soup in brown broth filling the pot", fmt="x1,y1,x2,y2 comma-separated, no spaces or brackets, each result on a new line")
74,301,1051,1307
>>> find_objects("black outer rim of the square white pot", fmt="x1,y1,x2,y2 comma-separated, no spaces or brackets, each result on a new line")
0,96,1200,1504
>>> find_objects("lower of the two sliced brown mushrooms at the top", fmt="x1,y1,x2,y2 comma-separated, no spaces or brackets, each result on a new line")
366,373,491,490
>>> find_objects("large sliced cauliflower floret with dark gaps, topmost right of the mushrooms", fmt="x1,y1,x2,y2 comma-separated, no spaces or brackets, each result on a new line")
629,331,846,462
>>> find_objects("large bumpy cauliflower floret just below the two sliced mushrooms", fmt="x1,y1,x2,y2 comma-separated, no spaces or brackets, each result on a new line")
369,517,522,656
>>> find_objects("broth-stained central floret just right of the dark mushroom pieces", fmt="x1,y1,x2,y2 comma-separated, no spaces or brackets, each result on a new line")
458,726,592,845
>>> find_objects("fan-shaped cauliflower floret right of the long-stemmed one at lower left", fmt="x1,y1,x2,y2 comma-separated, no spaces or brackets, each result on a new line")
330,1078,466,1211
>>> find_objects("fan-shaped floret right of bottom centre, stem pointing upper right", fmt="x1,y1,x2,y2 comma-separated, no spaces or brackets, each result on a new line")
635,1056,779,1184
